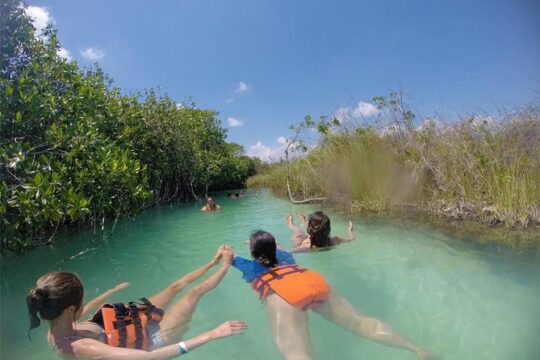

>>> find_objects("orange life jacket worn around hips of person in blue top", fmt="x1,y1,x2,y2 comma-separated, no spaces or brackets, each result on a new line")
251,264,331,310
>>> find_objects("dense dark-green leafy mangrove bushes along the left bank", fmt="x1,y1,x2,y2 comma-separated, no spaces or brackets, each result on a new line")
0,0,256,250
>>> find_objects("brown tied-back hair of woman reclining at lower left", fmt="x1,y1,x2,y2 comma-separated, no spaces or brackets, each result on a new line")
26,271,83,338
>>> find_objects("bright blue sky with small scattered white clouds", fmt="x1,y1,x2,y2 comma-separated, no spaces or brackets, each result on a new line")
23,0,540,158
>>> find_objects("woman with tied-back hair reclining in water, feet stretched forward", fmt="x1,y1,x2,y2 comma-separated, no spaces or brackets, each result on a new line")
27,246,247,360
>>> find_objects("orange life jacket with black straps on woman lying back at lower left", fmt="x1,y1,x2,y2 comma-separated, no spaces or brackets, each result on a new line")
91,298,163,350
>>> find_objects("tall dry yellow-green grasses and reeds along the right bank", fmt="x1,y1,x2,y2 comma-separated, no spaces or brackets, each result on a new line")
247,93,540,251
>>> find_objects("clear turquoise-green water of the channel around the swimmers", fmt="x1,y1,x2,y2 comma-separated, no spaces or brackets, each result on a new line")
0,193,540,360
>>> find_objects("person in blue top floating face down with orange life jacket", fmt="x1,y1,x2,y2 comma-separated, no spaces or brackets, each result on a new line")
232,230,436,360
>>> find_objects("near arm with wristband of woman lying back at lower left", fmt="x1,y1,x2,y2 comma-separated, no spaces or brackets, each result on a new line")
71,321,247,360
